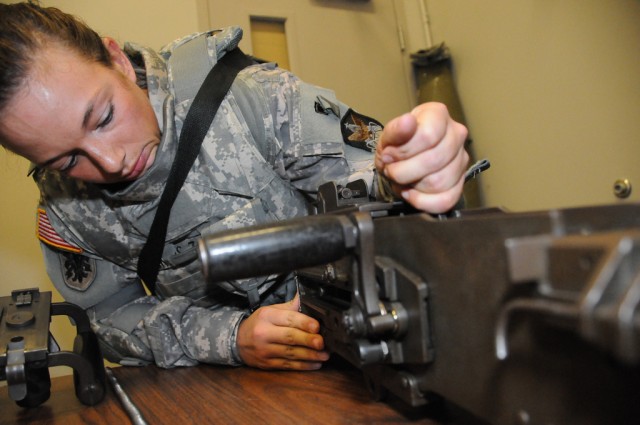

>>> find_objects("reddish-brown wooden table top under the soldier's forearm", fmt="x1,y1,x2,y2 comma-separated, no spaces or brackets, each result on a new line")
0,362,460,425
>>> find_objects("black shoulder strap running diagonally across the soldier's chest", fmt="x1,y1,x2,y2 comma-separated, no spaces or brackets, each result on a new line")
138,48,254,293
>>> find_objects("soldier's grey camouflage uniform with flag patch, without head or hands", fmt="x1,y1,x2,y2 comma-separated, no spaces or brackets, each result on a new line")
36,27,381,367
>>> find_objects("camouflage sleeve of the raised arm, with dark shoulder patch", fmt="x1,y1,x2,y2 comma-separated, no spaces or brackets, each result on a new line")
234,64,382,197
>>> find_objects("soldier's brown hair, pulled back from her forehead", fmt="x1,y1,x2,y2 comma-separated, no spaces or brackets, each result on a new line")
0,2,111,113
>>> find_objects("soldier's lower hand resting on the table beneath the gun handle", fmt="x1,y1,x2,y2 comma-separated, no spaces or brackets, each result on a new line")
236,295,329,370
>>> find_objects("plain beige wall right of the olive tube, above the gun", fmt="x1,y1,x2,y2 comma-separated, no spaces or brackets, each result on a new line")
426,0,640,211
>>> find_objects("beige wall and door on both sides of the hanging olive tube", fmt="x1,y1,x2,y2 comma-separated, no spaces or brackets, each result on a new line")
208,0,640,211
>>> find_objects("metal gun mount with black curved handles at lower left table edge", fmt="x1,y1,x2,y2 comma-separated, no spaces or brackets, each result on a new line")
0,288,106,408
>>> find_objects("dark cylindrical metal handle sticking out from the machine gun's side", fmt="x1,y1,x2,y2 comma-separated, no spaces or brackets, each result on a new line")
199,215,357,282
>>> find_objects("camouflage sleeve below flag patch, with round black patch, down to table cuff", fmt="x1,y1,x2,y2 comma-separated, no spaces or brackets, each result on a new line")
41,243,248,368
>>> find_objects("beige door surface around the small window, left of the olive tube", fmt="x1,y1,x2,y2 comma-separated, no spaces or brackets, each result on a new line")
208,0,413,122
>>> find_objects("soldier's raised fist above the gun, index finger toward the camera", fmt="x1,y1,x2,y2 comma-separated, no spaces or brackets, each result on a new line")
375,103,469,214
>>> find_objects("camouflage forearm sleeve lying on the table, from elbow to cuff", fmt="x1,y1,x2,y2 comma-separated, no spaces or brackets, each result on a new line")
94,296,247,368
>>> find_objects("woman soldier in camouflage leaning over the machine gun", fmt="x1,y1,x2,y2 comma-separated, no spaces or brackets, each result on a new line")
0,3,468,370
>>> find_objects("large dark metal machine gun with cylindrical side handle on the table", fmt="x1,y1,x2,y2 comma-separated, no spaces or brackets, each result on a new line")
200,184,640,424
